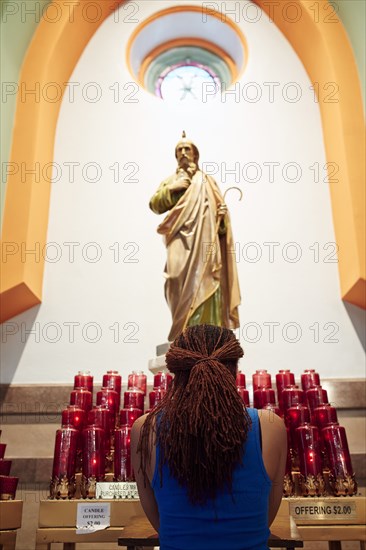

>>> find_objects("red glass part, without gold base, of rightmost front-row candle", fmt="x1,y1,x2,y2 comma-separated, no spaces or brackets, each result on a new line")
322,423,354,479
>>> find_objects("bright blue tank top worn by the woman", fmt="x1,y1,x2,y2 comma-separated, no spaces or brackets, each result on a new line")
151,408,272,550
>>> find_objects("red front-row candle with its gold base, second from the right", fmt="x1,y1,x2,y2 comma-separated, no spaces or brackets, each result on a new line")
296,424,325,496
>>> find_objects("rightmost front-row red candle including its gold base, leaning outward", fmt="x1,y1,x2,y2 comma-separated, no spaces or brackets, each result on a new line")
322,423,357,496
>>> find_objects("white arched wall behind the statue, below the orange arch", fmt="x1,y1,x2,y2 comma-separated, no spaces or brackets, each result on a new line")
2,2,364,383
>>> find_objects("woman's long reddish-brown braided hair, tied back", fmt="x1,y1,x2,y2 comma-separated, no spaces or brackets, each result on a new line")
138,325,251,504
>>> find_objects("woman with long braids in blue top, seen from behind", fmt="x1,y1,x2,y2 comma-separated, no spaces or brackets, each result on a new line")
131,325,287,550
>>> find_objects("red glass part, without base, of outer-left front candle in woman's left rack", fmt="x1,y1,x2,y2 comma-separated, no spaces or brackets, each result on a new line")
52,426,80,479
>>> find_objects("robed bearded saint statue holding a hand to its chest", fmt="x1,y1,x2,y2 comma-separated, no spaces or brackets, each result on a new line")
150,132,240,341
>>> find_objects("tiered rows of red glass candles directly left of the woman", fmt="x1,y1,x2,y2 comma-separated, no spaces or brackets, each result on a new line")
49,370,154,499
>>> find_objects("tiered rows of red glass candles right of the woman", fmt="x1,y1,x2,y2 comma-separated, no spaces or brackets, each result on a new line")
246,369,357,496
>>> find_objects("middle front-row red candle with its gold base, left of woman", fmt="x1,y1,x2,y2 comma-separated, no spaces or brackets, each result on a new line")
81,426,105,498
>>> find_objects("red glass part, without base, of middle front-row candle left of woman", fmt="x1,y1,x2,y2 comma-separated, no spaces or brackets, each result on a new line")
82,426,105,481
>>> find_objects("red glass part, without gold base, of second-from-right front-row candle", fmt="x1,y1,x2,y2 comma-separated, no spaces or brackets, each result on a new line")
296,424,322,478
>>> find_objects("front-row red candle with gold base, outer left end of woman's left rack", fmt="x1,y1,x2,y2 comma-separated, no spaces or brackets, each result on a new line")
50,426,80,499
